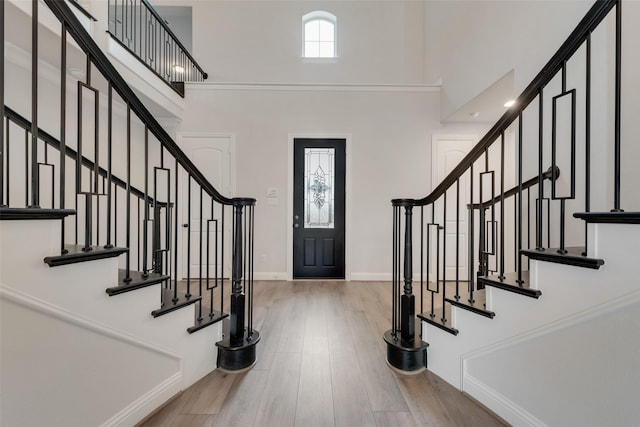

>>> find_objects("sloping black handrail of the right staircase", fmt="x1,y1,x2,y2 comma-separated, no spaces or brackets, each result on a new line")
415,0,620,206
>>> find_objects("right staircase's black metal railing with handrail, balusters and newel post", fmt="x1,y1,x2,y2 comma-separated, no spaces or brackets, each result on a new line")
384,0,621,371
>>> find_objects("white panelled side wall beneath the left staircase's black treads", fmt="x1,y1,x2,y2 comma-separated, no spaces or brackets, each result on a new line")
0,220,222,427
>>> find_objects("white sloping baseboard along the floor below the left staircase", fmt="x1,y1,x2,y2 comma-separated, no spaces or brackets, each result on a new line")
102,372,182,427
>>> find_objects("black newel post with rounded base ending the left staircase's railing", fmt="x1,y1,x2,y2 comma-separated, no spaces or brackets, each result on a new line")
216,198,260,372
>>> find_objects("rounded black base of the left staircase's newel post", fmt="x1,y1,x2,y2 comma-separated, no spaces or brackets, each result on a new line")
216,328,260,372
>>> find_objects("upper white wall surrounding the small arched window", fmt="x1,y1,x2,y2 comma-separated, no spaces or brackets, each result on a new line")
154,0,424,84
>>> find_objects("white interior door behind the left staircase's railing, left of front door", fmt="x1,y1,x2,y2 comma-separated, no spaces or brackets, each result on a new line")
180,134,233,278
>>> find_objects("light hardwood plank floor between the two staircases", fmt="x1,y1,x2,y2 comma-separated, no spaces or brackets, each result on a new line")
141,281,504,427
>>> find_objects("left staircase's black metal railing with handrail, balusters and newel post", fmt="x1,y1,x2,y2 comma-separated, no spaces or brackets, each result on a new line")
0,0,259,369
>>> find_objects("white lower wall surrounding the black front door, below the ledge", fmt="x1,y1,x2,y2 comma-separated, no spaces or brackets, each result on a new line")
178,84,488,279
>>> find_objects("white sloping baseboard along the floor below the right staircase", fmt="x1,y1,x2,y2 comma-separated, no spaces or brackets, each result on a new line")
462,374,546,427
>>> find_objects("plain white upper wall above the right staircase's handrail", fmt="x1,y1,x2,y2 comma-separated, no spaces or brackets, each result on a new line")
425,0,593,117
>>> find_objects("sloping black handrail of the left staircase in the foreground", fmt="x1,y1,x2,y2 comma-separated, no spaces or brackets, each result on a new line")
44,0,235,205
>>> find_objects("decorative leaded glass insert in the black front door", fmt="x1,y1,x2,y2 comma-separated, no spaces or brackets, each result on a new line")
304,148,335,228
